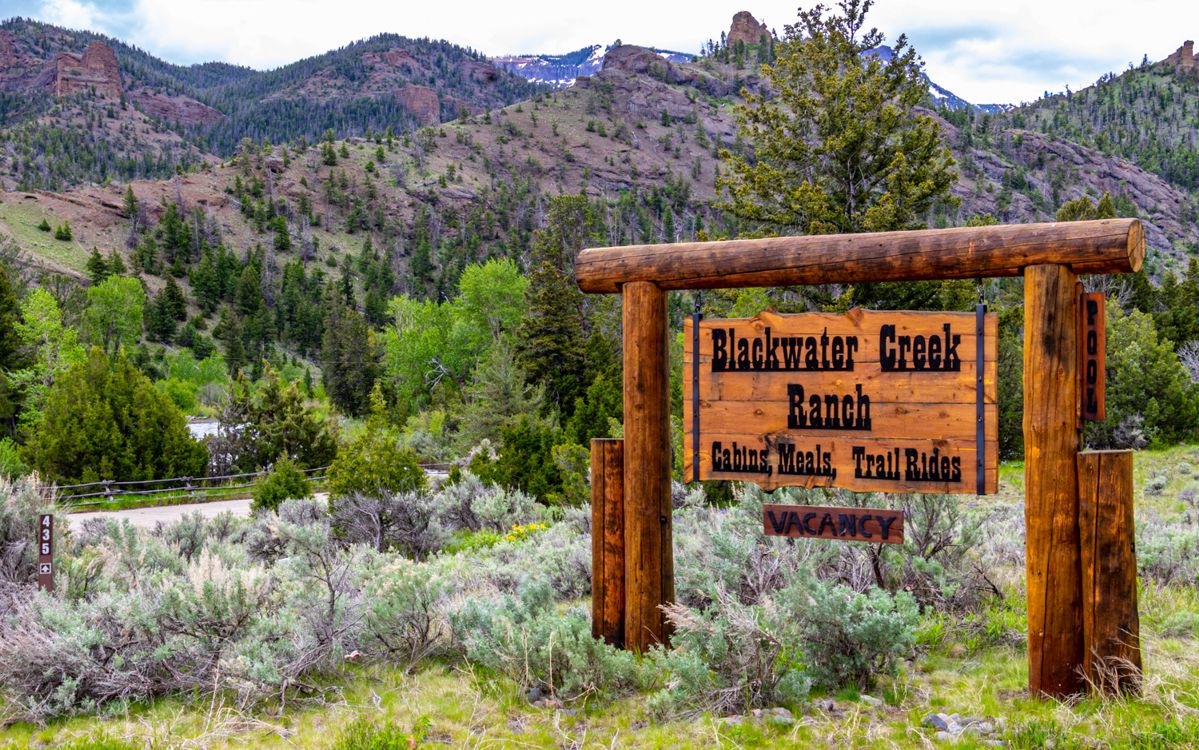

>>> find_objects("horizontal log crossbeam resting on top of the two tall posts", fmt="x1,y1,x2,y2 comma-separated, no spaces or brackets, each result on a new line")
574,219,1145,294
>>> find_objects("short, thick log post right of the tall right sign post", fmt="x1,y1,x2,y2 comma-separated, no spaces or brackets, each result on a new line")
1078,450,1141,695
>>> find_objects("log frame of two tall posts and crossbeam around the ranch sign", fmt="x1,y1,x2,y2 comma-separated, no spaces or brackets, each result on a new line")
574,219,1145,696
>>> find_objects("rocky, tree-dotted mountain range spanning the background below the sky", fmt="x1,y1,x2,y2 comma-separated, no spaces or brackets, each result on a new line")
0,14,1199,295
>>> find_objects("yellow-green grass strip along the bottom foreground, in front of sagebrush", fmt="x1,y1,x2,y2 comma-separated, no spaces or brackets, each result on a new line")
0,636,1199,750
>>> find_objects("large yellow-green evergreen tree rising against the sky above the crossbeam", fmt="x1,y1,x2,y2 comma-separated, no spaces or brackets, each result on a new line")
717,0,956,235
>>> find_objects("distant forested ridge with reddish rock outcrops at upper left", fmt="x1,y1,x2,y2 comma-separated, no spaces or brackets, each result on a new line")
0,18,540,189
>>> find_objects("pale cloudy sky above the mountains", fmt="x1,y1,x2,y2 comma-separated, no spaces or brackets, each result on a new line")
0,0,1199,103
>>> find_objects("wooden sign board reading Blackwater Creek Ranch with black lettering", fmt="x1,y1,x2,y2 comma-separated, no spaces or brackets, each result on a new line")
683,309,999,494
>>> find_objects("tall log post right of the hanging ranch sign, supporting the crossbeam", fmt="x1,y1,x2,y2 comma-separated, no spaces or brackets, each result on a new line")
1024,265,1084,697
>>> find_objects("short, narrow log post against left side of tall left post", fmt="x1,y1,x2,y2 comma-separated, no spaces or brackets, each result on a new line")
591,437,625,647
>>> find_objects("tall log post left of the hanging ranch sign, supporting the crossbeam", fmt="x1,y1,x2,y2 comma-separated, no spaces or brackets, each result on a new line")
621,282,674,653
